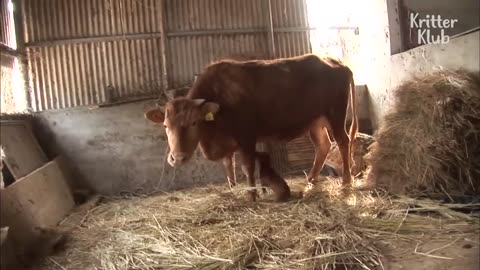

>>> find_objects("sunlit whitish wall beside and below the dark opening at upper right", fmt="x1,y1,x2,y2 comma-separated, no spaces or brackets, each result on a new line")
360,0,480,128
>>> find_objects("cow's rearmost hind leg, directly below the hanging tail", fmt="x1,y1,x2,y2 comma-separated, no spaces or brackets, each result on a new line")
332,125,352,187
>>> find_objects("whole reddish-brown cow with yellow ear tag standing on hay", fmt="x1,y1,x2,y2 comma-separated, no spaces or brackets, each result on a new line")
145,54,358,201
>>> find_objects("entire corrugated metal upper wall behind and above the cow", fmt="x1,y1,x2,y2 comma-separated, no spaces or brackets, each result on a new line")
22,0,311,111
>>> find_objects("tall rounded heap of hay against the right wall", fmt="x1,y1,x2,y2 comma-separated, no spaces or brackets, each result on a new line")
368,71,480,194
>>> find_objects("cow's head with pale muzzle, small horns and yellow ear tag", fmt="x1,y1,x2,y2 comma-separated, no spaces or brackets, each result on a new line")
145,98,219,167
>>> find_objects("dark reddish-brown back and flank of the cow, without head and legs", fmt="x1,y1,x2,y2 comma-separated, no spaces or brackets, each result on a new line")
188,55,351,139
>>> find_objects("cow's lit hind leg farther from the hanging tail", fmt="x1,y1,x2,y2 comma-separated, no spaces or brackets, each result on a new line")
307,117,332,184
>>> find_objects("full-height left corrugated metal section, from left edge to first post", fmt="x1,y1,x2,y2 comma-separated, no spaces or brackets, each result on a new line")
24,0,163,111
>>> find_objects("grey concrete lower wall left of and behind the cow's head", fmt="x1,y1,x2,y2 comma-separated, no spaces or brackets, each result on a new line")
35,102,226,194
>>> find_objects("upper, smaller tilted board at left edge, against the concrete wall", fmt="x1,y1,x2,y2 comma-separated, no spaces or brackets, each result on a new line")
0,120,48,180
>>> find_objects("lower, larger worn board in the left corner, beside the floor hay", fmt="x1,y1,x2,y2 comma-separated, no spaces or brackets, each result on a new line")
0,159,74,243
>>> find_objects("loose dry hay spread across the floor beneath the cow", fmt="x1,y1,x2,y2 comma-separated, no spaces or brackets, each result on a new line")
40,179,478,270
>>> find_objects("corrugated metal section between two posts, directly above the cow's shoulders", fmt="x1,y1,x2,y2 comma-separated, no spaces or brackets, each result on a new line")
166,0,269,87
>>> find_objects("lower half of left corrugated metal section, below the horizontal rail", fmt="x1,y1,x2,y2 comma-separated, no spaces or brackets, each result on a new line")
28,38,162,110
